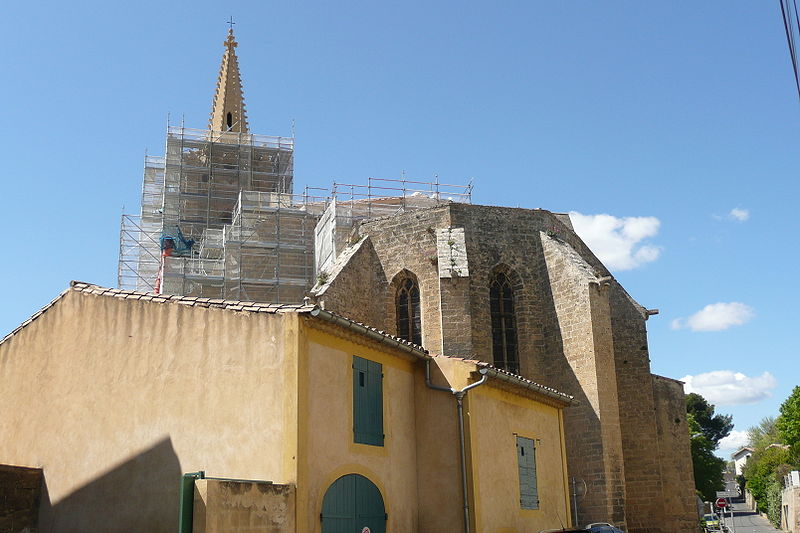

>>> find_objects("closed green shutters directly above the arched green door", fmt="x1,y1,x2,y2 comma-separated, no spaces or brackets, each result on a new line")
353,356,384,446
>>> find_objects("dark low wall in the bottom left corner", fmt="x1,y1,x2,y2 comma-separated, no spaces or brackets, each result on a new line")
0,465,42,533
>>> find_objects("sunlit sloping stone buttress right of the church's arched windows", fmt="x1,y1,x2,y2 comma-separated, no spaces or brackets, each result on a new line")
543,232,625,523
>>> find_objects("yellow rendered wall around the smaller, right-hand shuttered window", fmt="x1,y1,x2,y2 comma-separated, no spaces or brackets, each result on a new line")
467,380,571,533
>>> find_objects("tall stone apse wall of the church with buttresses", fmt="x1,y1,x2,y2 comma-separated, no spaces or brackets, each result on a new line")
312,204,693,532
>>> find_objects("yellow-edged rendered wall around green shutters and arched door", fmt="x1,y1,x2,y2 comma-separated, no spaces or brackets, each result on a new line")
297,319,417,533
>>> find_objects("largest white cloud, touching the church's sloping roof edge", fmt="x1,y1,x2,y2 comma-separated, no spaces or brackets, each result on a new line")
569,211,661,270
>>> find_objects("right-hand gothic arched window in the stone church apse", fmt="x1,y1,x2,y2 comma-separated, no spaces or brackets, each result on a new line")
489,272,519,374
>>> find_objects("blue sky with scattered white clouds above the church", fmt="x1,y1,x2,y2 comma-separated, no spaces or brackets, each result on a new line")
0,1,800,456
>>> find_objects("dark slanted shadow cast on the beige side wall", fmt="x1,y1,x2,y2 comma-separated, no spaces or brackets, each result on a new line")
39,437,181,533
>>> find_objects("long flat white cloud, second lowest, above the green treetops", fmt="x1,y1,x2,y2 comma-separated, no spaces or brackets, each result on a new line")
681,370,778,405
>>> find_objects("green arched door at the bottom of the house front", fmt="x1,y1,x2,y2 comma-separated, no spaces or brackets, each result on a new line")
322,474,386,533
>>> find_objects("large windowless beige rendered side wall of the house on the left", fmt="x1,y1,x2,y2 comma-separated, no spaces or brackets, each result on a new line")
0,291,297,532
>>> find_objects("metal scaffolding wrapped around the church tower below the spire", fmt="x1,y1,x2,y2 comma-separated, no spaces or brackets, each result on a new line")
118,126,472,303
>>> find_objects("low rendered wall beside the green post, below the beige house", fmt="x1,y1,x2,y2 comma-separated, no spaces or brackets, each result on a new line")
192,479,297,533
